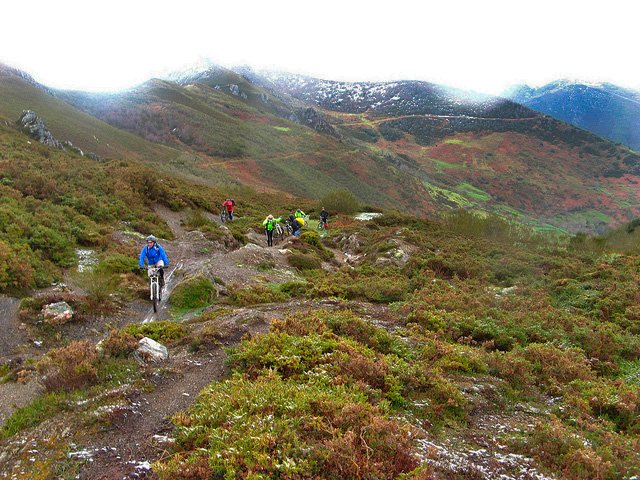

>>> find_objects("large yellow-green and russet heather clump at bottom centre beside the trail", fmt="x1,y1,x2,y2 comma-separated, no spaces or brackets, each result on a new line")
154,374,418,479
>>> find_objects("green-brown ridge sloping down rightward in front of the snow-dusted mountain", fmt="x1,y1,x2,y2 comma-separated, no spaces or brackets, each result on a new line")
58,80,434,214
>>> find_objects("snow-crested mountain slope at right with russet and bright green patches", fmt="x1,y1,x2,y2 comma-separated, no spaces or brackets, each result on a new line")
241,71,640,231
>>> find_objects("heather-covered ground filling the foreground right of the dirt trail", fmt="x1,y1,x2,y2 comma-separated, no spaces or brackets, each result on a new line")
155,214,640,479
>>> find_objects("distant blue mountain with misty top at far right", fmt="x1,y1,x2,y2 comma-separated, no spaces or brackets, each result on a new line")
504,80,640,150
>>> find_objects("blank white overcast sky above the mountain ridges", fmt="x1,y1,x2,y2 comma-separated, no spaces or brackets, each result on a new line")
0,0,640,93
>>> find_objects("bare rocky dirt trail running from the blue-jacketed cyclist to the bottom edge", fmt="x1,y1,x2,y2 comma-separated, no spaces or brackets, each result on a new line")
73,208,312,480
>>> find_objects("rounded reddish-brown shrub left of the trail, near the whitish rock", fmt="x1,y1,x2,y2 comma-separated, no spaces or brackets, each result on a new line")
37,341,99,391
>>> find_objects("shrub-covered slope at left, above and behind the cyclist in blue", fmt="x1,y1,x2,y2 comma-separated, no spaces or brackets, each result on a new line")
0,124,312,291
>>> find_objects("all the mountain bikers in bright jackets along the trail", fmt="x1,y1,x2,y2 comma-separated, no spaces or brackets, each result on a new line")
138,198,329,290
